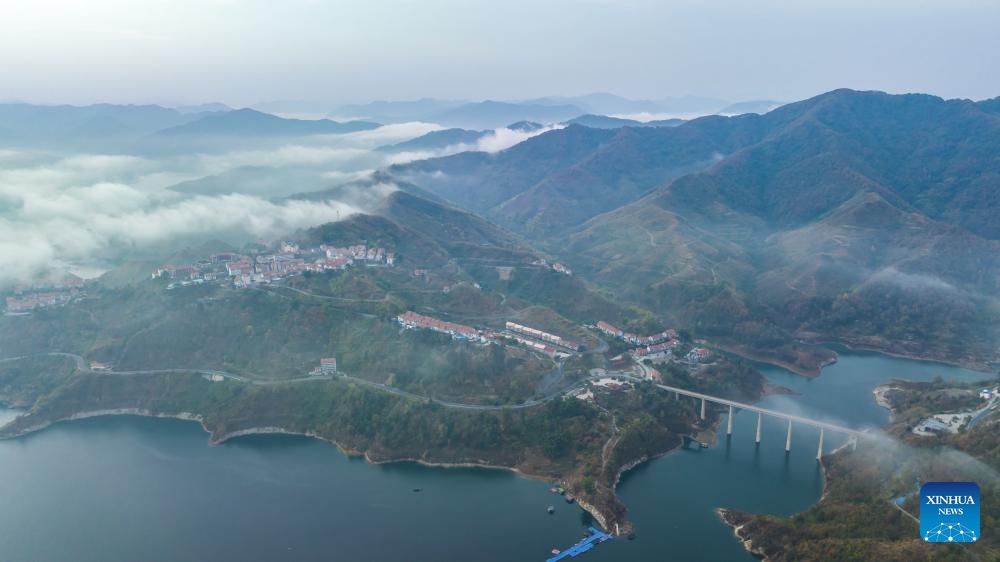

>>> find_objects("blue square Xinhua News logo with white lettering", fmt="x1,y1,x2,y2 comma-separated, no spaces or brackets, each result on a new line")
920,482,979,542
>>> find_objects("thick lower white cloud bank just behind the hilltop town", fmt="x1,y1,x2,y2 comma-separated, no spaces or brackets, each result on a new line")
0,178,361,287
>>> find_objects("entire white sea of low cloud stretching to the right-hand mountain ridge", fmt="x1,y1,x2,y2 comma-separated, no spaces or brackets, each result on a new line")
0,117,553,289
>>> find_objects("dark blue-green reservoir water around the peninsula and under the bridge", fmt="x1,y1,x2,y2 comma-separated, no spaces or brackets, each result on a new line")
0,349,988,562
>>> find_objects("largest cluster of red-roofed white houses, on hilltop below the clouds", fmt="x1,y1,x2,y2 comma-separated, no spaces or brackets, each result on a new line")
152,238,396,289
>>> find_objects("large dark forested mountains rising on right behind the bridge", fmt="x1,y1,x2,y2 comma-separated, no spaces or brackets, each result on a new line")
390,90,1000,368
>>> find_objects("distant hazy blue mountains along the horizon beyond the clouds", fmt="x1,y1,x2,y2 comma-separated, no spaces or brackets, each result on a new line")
0,94,788,152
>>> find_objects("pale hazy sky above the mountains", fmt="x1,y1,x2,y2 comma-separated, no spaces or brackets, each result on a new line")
0,0,1000,106
